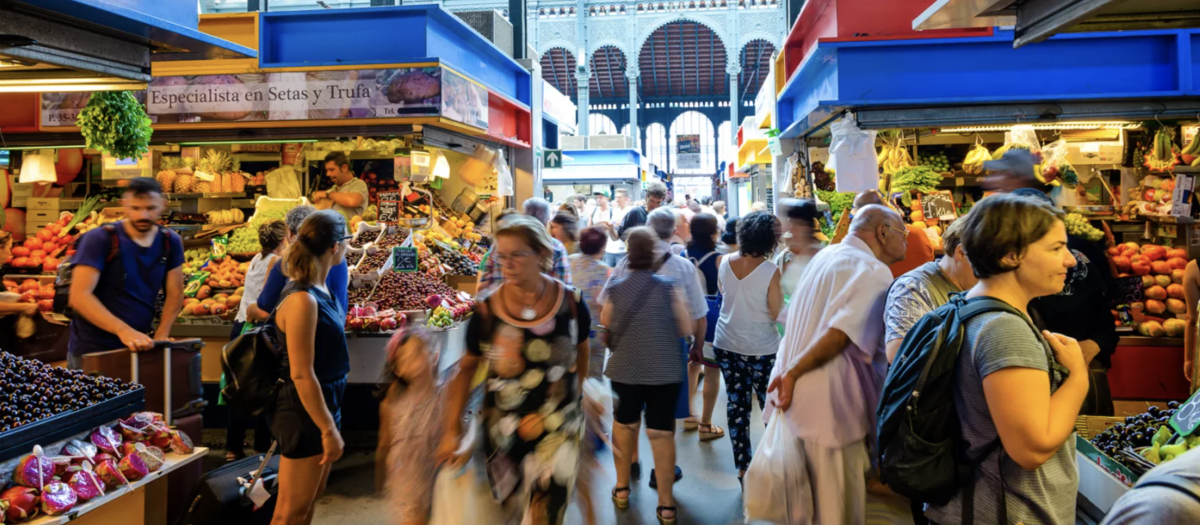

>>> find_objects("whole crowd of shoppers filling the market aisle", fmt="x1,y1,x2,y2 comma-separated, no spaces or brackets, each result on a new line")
63,173,1180,525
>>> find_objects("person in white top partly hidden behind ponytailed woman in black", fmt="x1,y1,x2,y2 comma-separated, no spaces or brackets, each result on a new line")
222,221,288,461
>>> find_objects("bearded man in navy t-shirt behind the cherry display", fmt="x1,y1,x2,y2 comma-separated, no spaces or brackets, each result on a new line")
67,177,184,369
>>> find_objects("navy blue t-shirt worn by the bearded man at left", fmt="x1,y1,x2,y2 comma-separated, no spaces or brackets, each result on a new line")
67,222,184,355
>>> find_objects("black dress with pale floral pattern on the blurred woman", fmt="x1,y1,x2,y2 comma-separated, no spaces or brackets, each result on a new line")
467,284,592,525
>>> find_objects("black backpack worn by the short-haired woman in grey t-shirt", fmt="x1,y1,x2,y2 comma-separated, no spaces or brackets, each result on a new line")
876,294,1052,524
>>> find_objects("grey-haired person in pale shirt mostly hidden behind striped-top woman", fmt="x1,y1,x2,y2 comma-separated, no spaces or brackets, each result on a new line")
598,207,708,488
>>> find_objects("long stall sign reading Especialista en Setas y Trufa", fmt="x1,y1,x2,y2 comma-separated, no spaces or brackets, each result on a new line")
41,67,488,129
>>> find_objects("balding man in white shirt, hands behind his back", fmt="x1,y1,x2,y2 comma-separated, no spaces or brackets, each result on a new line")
763,205,908,525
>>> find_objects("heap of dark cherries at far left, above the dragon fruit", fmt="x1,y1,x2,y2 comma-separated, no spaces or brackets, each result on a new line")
0,352,142,432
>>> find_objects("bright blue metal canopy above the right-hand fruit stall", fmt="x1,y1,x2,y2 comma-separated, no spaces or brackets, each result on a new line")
776,29,1200,138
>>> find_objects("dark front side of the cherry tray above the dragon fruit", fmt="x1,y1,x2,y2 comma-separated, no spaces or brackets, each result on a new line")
0,388,146,461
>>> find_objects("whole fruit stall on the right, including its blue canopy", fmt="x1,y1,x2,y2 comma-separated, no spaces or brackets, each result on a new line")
773,6,1200,514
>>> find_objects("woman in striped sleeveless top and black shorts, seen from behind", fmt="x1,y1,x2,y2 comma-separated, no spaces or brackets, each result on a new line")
601,228,694,524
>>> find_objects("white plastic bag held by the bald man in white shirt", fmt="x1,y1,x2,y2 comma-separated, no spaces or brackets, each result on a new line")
742,410,812,525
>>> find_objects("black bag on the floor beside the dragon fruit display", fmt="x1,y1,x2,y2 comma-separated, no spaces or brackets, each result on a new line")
174,443,280,525
